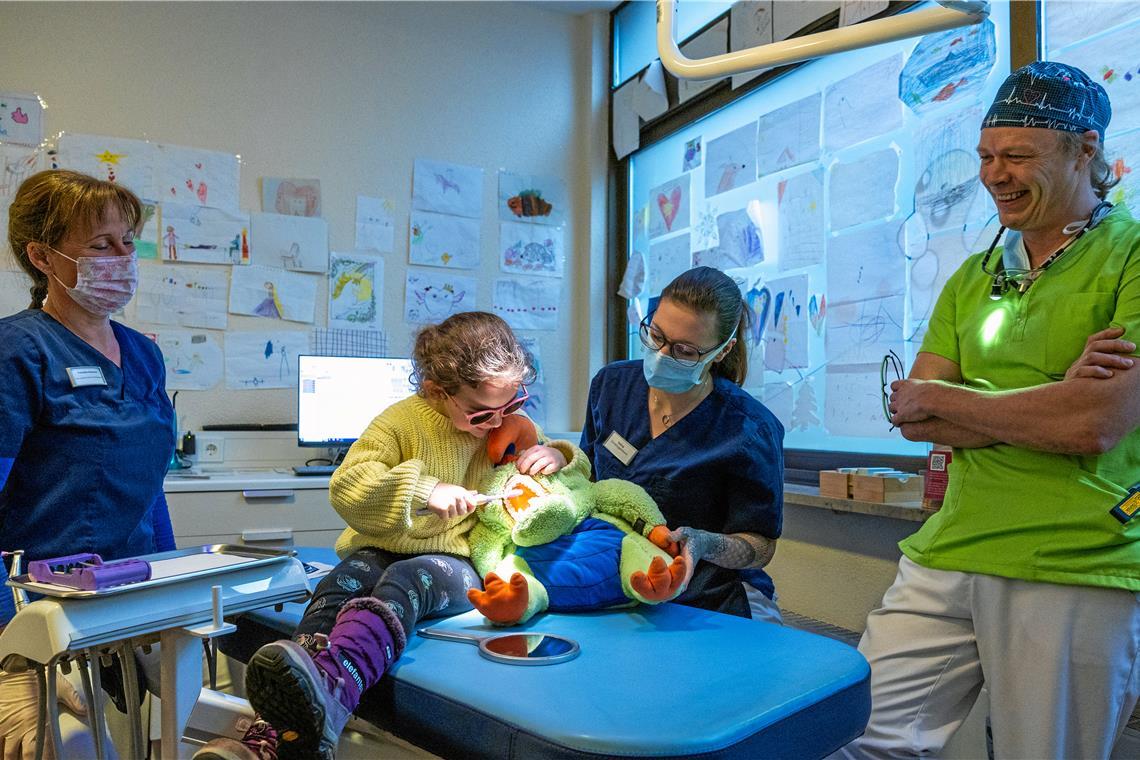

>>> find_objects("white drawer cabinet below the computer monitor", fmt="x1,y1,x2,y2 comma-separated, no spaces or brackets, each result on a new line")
163,467,344,547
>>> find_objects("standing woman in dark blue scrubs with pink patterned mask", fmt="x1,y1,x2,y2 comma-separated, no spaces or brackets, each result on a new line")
0,170,174,757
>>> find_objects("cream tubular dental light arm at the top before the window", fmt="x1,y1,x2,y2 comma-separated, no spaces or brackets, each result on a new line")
657,0,990,80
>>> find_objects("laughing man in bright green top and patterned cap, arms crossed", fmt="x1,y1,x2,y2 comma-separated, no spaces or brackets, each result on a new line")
842,62,1140,758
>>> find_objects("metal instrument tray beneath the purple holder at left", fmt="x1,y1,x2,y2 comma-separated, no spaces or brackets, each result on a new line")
7,544,296,599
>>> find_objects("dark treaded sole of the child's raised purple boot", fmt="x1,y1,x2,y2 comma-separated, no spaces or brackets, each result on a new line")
245,641,335,760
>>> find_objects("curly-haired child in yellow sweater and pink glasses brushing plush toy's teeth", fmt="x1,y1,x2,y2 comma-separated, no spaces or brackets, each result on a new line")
195,312,579,760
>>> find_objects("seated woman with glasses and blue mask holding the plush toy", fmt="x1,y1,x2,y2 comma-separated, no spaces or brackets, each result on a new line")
581,267,783,621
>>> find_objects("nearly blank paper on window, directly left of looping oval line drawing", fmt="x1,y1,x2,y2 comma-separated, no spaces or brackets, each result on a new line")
828,147,898,232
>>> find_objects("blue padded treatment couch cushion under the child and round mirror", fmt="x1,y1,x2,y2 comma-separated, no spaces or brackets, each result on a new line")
221,554,870,759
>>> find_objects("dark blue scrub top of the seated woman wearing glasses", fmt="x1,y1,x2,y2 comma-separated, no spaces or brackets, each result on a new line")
581,359,783,618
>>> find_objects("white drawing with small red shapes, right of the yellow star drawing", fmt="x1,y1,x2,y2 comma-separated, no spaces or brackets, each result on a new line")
148,142,238,212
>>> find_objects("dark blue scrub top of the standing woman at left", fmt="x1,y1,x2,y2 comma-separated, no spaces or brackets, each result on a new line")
0,310,174,621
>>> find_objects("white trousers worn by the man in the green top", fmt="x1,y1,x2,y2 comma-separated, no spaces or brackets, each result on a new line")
833,557,1140,759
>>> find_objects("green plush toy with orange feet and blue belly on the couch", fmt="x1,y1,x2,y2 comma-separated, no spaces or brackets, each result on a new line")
467,415,685,626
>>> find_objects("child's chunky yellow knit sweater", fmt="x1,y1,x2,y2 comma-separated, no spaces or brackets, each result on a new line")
328,395,580,558
